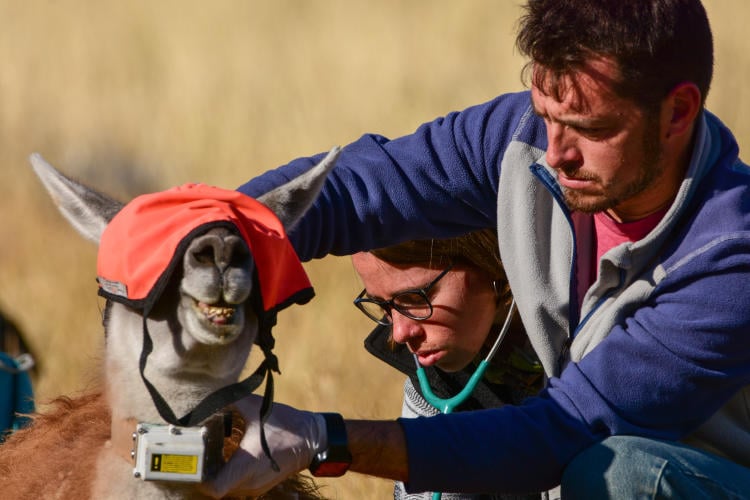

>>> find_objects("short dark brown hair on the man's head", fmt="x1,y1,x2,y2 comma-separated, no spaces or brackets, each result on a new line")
516,0,713,110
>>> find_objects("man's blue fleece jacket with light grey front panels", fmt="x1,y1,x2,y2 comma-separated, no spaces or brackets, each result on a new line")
240,92,750,492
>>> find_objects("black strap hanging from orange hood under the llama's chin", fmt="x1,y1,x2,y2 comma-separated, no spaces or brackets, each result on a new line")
138,311,281,472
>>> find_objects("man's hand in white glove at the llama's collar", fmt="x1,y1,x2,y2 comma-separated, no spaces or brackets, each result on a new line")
201,394,328,498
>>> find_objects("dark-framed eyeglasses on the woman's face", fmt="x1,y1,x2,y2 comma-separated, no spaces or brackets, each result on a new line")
354,264,453,326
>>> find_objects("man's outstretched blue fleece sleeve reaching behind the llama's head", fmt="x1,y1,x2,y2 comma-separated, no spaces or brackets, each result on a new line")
238,93,530,261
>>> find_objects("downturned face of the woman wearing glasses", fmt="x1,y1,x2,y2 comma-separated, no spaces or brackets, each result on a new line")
352,252,496,372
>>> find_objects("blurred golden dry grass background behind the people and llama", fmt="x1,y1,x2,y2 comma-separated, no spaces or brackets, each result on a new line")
0,0,750,499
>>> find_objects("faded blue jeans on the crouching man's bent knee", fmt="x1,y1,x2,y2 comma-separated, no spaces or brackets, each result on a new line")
561,436,750,500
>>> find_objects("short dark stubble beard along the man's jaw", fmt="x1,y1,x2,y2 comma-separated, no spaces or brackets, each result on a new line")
562,113,664,214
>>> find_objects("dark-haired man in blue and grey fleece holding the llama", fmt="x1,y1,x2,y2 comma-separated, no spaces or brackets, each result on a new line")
203,0,750,498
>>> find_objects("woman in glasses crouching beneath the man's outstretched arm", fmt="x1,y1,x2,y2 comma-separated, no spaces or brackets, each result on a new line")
352,230,542,500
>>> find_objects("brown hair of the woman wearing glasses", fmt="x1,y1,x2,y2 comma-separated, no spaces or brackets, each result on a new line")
370,229,510,301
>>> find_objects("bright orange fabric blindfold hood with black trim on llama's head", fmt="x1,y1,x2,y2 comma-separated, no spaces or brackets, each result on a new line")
97,184,314,312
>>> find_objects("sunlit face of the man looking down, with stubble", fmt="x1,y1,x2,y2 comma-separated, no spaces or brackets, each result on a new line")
531,59,672,220
